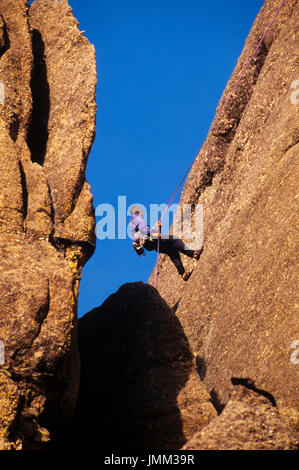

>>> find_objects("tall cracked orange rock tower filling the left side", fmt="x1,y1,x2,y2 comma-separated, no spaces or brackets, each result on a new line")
0,0,96,449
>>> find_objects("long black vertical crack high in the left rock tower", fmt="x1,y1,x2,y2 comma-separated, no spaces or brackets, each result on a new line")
27,29,50,165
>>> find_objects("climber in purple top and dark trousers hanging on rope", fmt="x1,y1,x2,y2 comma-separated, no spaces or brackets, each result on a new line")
129,205,203,281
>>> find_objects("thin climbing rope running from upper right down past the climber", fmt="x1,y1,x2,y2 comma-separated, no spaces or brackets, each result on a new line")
153,0,286,287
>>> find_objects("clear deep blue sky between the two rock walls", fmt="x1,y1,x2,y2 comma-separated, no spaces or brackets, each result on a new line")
42,0,263,316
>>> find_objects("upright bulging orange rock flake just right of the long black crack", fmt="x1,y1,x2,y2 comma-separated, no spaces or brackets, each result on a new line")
29,0,97,226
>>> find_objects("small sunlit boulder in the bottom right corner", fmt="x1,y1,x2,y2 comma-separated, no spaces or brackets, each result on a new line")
183,385,297,450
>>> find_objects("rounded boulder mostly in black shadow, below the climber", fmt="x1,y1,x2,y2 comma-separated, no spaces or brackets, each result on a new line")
62,282,217,451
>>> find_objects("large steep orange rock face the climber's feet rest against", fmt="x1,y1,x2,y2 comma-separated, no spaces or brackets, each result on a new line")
150,0,299,445
